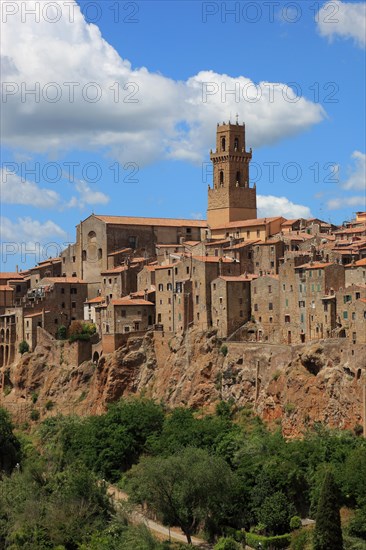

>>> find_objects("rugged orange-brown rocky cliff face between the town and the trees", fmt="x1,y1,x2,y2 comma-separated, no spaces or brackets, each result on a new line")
1,330,366,436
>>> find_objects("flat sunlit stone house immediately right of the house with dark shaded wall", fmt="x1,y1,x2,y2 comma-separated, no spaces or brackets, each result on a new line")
251,275,280,343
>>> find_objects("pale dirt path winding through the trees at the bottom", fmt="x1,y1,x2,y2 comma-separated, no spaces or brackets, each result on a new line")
108,485,207,549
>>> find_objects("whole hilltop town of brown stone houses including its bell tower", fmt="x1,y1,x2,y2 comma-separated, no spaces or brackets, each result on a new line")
0,122,366,378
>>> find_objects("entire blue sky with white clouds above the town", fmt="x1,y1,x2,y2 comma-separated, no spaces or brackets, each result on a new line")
1,0,366,271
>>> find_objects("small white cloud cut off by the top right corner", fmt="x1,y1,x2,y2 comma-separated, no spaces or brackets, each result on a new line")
317,0,366,47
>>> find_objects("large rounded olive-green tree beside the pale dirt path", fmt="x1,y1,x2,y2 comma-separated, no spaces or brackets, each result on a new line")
128,448,236,544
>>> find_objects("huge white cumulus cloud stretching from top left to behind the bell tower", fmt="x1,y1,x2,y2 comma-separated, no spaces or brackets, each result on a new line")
2,0,325,165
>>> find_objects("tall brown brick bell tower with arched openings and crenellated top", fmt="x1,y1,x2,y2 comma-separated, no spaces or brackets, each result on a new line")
207,122,257,227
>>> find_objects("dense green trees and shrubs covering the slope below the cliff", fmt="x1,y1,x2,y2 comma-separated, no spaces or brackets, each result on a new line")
0,399,366,550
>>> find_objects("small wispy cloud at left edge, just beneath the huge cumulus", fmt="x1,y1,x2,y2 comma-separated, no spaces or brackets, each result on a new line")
0,168,61,208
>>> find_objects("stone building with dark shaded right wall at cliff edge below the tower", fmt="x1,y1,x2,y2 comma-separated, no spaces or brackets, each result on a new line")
211,275,252,338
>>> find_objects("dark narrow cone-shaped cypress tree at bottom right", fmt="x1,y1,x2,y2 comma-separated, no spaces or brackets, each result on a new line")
314,471,343,550
